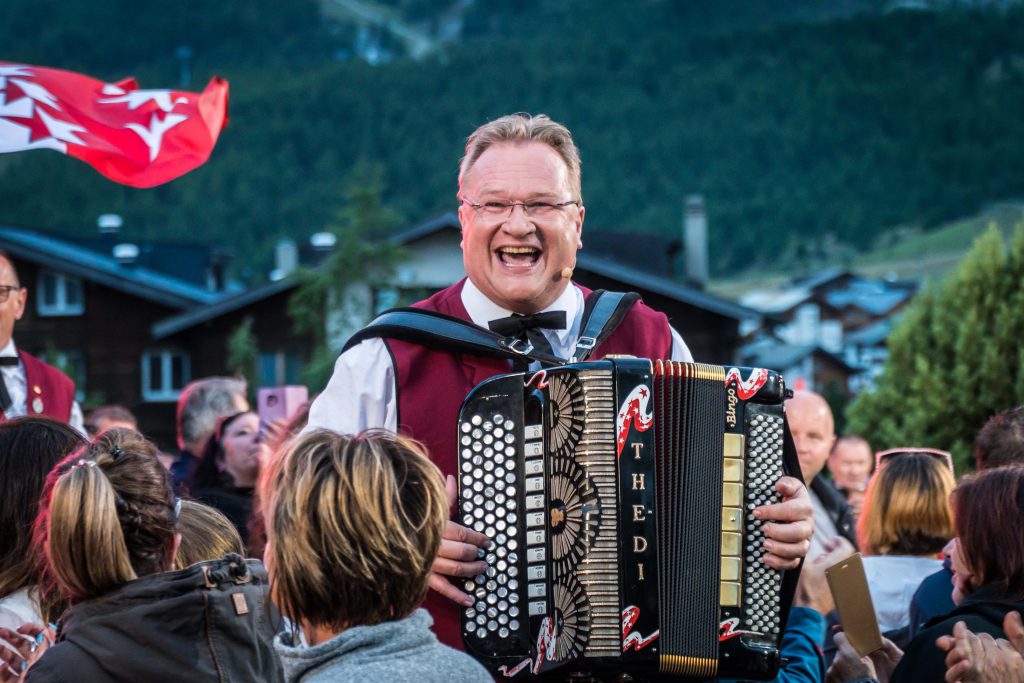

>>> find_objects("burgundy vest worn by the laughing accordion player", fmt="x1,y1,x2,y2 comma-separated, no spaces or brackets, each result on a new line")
385,279,672,650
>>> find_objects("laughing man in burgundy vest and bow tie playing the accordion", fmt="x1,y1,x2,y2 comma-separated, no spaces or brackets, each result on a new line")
309,115,812,648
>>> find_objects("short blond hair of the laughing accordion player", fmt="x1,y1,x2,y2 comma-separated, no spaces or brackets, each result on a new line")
459,114,583,202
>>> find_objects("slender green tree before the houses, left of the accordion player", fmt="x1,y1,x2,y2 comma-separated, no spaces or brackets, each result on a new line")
288,160,403,387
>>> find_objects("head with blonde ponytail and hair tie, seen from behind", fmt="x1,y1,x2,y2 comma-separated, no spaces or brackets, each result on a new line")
35,429,178,602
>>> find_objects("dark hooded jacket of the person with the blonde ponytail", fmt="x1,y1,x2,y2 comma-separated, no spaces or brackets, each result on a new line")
26,555,282,683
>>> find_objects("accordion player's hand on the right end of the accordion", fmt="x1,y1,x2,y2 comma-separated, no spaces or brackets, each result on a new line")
754,477,814,569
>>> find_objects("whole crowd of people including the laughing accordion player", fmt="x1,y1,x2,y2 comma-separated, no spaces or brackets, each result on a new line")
0,115,1024,683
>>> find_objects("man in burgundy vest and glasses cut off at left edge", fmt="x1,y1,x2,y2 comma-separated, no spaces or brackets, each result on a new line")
0,252,85,433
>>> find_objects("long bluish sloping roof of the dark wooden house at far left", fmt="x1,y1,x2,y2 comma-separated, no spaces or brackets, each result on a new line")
0,225,224,308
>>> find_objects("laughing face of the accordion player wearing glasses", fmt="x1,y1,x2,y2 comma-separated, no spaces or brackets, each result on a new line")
459,142,584,313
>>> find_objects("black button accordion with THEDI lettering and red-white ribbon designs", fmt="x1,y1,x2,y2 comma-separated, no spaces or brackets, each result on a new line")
457,357,799,680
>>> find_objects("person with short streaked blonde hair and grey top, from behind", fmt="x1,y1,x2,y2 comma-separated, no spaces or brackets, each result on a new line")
259,430,490,683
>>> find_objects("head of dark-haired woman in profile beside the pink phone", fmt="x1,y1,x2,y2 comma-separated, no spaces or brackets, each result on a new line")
193,411,266,490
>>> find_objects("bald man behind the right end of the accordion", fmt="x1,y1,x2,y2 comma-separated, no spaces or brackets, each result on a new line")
785,391,857,558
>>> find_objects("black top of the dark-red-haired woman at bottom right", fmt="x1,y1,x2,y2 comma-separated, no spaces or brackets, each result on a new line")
889,586,1024,683
